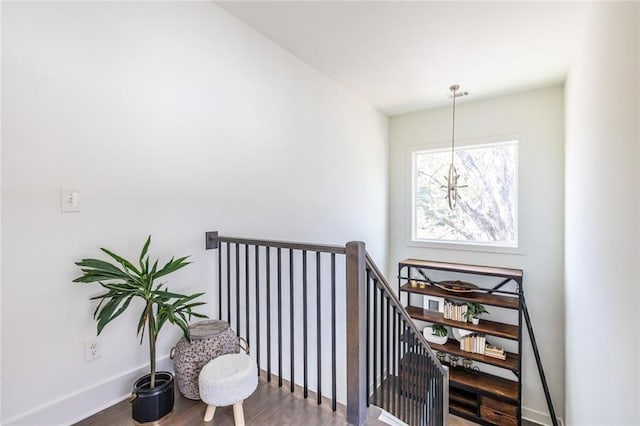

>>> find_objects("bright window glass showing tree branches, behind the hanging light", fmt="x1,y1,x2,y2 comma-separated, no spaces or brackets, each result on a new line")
411,141,518,247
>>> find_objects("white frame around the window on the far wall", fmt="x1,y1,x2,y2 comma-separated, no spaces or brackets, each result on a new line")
405,135,525,254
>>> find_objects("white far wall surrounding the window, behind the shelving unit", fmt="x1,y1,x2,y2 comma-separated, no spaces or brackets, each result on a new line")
389,87,564,423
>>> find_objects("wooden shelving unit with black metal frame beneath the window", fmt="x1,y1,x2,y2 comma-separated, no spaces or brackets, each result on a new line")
398,259,523,425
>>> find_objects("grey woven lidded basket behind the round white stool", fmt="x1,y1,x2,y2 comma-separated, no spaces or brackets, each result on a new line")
170,320,239,399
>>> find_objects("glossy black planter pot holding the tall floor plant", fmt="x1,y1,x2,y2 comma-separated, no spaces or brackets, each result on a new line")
131,371,174,423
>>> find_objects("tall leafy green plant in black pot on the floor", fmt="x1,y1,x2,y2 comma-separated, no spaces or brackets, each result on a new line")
73,236,206,423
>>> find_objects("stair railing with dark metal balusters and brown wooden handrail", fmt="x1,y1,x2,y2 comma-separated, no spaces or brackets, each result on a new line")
206,232,448,425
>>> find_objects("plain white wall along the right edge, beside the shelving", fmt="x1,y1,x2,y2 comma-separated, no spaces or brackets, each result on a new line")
565,2,640,425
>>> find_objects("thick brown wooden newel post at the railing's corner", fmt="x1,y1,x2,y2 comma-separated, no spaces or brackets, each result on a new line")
346,241,367,426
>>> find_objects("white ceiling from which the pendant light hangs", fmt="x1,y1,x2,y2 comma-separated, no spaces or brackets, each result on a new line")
216,1,588,115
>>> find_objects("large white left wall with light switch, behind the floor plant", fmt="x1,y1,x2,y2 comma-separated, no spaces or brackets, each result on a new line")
2,2,388,424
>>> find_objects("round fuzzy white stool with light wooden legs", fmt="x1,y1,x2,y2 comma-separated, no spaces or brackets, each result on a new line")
198,353,258,426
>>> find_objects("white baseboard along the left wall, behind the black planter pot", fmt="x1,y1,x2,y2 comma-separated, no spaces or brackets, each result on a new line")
2,356,173,426
